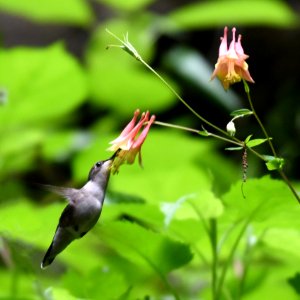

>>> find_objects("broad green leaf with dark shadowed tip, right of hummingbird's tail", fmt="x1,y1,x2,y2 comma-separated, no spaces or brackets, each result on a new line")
99,222,192,275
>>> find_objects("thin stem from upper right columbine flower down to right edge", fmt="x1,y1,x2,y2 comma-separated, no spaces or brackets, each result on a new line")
243,79,300,204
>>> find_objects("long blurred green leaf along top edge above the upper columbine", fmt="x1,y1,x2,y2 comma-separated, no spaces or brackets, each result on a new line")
169,0,297,29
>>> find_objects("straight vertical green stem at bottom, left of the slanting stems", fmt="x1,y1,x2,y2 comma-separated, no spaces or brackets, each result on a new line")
210,219,218,300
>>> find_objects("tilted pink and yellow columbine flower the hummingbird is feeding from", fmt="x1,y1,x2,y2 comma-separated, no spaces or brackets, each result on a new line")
108,109,155,174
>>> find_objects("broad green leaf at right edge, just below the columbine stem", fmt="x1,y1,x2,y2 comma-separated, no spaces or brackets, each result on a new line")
223,177,300,229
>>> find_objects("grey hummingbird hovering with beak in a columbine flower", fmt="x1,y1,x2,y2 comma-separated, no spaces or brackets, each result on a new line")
41,151,118,269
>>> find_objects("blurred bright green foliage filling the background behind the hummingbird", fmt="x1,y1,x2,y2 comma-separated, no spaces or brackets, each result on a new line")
0,0,300,300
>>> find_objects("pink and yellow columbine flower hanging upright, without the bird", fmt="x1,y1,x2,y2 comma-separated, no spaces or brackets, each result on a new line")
211,27,254,90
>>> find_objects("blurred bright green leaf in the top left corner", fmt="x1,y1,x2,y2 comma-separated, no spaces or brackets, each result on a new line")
0,0,94,26
